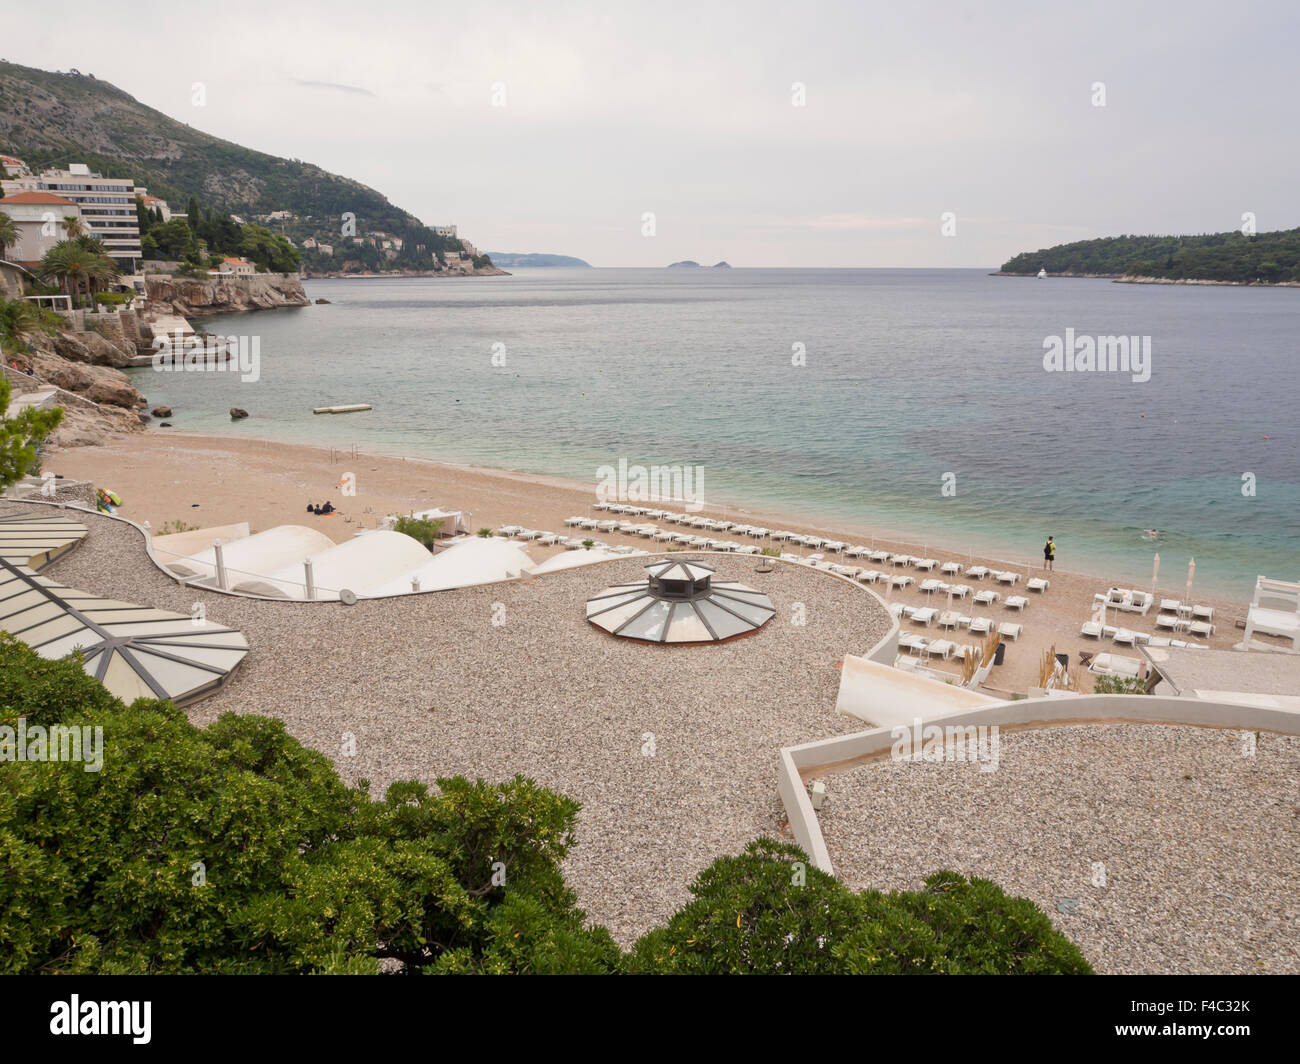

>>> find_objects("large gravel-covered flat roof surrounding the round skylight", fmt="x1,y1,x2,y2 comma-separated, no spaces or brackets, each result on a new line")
31,507,889,946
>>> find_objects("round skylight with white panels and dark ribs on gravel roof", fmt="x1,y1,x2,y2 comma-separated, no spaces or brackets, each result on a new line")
586,561,776,644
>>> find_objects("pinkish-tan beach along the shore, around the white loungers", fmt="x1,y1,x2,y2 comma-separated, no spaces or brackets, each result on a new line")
46,432,1268,693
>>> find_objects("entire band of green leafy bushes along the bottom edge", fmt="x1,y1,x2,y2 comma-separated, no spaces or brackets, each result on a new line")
0,633,1091,974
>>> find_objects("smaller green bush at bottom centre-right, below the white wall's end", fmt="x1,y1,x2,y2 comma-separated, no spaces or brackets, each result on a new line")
627,839,1092,974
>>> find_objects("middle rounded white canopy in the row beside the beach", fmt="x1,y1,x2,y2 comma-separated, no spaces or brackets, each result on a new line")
228,529,429,598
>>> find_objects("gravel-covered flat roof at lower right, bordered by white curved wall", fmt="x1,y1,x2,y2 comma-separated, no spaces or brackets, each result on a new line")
820,725,1300,974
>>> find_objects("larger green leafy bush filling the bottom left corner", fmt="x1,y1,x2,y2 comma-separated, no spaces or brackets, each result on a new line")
0,636,619,973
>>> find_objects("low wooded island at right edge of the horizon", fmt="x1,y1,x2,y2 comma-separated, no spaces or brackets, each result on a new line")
998,229,1300,286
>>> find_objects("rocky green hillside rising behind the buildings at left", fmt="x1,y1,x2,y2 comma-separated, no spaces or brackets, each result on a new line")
0,62,486,268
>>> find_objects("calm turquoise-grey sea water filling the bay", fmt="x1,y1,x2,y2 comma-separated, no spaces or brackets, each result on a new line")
133,269,1300,598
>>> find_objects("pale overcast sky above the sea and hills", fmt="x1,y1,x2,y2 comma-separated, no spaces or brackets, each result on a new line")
0,0,1300,268
